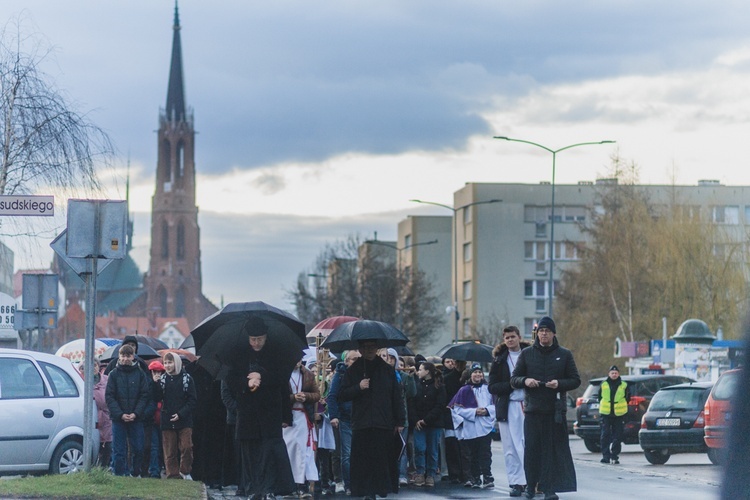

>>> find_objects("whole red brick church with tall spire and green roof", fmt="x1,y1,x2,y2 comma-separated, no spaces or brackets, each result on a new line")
53,7,218,343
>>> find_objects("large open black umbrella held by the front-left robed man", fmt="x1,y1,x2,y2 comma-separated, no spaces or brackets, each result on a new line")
191,302,307,379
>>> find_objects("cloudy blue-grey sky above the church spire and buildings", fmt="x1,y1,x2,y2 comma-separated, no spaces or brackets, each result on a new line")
2,0,750,307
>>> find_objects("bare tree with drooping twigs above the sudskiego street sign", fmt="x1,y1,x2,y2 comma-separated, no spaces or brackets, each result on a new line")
0,18,113,244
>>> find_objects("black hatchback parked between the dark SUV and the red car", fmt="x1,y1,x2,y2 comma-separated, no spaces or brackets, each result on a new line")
638,382,713,465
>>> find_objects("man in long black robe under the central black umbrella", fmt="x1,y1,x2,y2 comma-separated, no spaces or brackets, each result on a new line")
339,341,406,500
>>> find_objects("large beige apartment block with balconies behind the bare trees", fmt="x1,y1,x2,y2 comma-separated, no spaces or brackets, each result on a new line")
398,179,750,339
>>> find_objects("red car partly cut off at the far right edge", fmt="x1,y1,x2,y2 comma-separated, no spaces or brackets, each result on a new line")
703,369,741,464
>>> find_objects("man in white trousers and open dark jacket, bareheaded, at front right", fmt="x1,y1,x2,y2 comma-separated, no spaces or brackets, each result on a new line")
489,325,530,497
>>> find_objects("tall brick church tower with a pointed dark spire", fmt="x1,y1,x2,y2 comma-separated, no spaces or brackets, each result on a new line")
146,5,217,328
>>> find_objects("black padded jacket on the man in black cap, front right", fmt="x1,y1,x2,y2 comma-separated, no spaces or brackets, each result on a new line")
510,337,581,421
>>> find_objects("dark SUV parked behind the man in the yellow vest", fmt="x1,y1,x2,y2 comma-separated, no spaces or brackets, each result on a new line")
573,375,694,453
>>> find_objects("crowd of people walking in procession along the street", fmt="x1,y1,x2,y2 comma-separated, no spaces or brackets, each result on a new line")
83,317,588,500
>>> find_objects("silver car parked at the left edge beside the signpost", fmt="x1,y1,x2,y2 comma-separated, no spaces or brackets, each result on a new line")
0,348,99,475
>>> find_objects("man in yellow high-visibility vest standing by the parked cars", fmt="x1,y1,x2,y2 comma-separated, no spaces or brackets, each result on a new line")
599,365,630,464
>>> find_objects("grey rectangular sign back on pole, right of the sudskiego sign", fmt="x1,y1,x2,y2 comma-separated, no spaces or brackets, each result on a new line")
65,200,128,259
